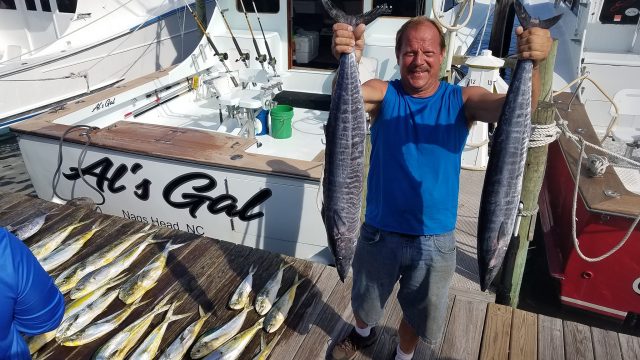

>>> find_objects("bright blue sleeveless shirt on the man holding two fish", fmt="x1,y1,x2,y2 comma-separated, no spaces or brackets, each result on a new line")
365,80,469,235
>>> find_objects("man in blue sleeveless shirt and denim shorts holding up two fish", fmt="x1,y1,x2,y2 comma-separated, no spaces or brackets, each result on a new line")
332,10,552,360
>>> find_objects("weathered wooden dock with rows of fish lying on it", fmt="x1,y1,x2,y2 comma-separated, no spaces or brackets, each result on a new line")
0,193,640,360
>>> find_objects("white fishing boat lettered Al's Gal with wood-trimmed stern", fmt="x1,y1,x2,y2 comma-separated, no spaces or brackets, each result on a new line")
12,0,489,263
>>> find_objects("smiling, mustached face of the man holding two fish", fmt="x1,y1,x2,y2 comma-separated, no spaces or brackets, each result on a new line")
398,23,444,96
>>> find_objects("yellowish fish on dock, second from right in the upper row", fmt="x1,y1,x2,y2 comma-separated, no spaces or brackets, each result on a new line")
69,236,166,299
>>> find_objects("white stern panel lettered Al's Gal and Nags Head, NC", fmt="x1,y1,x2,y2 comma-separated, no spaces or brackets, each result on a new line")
19,134,331,263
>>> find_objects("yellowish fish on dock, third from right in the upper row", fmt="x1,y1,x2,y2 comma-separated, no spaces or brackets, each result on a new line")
56,225,157,294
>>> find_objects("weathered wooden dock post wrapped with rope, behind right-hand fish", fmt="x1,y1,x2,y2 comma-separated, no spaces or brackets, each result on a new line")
496,40,558,307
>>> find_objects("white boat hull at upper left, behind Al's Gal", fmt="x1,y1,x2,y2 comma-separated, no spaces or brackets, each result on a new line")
0,0,213,129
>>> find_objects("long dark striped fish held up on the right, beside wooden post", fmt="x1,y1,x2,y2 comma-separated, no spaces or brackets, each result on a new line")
478,0,560,291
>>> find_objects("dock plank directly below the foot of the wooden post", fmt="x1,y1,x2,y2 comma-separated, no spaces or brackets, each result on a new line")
480,303,513,360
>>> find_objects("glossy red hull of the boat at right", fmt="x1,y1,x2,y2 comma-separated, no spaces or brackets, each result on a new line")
539,142,640,319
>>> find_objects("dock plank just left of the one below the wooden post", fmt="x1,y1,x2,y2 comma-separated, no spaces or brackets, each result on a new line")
440,296,487,360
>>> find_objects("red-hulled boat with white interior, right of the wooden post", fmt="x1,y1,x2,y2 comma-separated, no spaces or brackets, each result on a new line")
529,0,640,320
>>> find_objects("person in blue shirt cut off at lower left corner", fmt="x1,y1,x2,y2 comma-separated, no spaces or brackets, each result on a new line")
0,228,64,359
